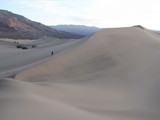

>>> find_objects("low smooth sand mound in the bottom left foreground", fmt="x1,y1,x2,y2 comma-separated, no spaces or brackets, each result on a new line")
0,79,109,120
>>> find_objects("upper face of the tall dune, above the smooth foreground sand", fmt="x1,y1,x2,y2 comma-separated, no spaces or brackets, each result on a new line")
16,27,160,81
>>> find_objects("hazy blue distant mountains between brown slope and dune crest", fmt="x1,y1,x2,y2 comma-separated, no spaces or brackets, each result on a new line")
51,25,100,36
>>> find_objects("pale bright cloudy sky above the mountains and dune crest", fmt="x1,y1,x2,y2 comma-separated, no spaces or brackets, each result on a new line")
0,0,160,30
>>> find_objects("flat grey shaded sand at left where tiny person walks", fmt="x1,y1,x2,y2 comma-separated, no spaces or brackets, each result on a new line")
0,38,86,77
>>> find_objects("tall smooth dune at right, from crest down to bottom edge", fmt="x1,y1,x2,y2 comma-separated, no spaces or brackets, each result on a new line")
15,27,160,120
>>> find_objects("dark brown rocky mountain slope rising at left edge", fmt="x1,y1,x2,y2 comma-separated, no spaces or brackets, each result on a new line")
0,10,82,39
